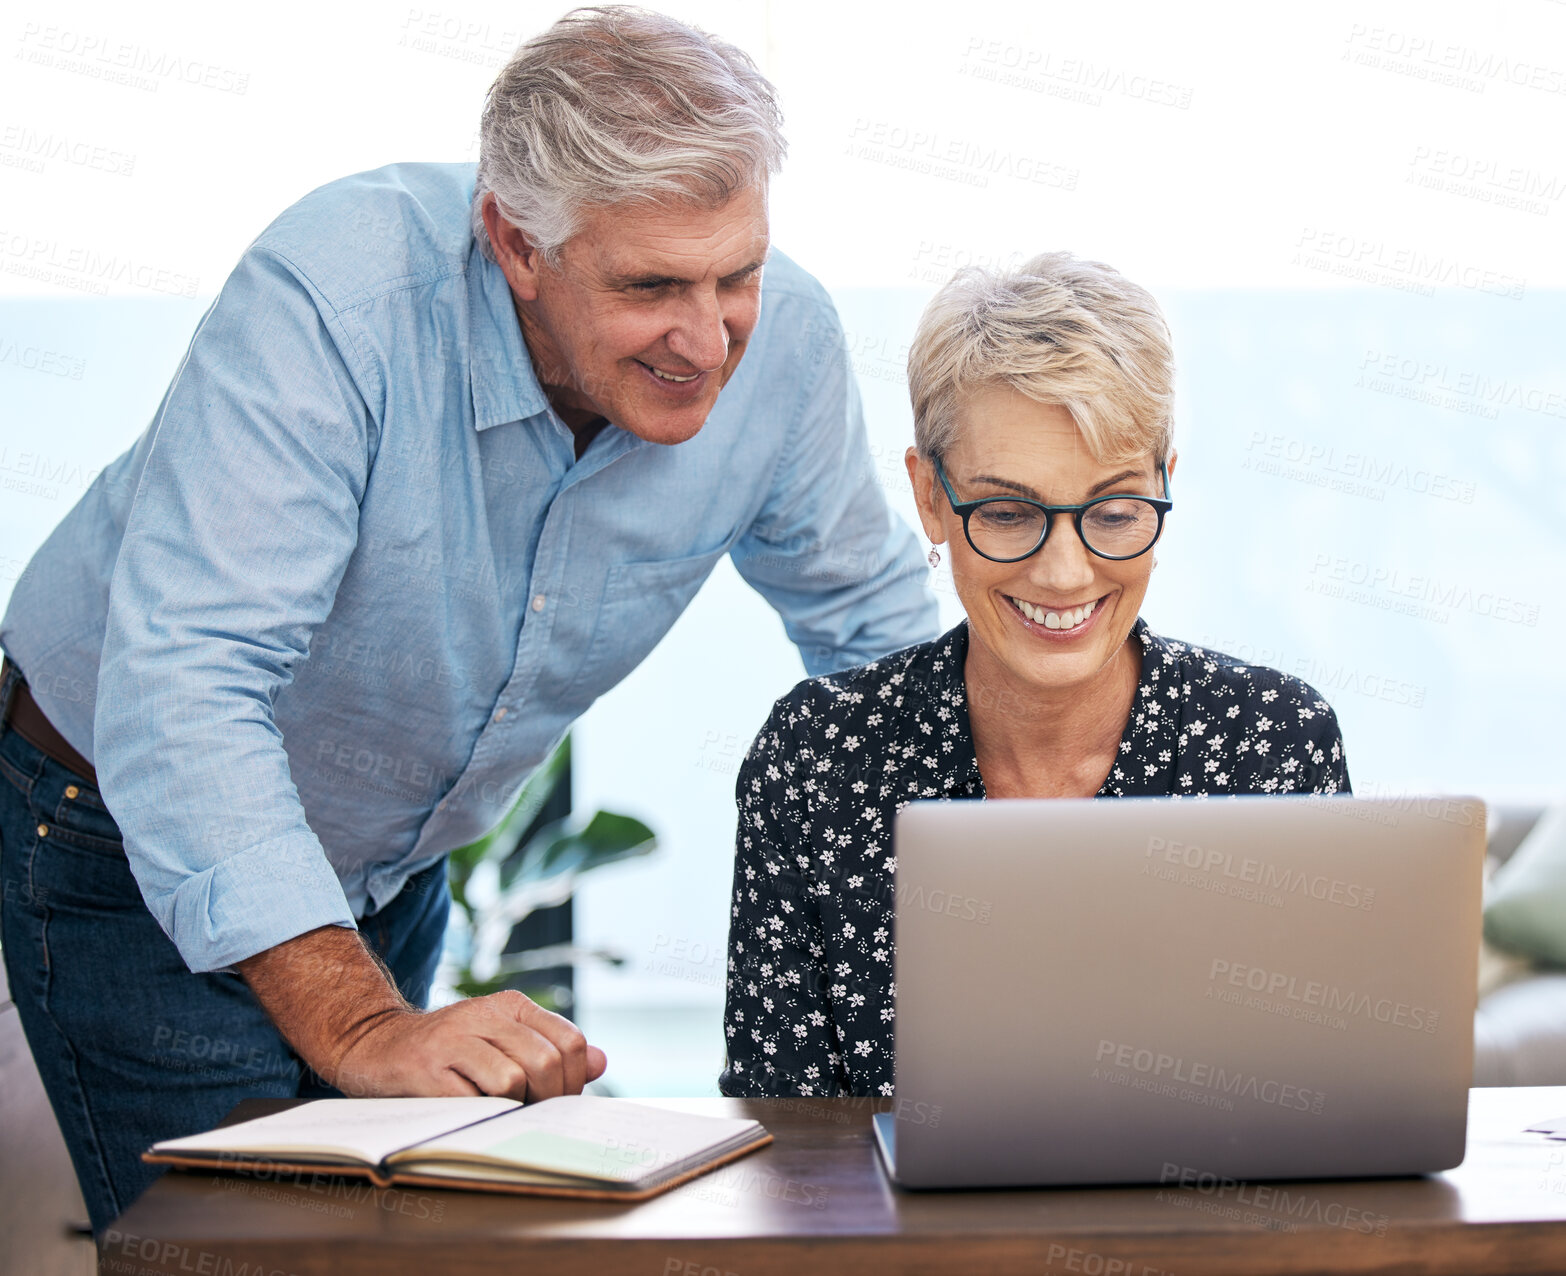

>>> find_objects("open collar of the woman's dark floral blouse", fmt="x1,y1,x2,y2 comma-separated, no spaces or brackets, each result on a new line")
908,615,1182,797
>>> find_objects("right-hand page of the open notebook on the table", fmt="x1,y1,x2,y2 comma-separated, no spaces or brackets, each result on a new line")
398,1094,760,1182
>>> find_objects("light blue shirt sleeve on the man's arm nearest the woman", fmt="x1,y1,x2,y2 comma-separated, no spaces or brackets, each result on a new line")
731,299,938,676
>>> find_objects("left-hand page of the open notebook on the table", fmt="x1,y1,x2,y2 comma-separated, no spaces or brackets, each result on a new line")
153,1098,521,1165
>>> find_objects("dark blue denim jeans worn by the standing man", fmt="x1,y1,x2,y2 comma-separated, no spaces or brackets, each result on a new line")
0,663,451,1234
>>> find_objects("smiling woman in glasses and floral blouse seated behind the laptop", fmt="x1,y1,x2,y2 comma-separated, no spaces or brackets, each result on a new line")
720,254,1348,1094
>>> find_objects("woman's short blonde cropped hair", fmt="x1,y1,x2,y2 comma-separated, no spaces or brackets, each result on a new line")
908,252,1175,463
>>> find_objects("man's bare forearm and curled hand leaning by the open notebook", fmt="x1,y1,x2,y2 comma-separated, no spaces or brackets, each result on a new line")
238,925,606,1101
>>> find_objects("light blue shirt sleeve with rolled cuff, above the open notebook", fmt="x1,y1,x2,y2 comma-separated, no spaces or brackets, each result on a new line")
92,247,381,972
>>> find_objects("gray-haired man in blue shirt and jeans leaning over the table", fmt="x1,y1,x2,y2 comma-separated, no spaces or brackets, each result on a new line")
0,9,935,1229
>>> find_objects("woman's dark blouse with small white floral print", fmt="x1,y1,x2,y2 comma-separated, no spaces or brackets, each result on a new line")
719,618,1350,1096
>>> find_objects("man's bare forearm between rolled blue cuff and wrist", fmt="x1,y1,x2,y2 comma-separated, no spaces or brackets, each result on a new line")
238,925,413,1085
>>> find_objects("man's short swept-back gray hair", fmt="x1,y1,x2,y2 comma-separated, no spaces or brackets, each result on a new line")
471,5,786,265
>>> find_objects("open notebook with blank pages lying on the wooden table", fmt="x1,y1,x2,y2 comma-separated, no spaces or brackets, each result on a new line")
141,1094,772,1201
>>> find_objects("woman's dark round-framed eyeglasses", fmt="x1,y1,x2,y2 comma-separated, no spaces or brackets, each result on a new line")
935,457,1175,562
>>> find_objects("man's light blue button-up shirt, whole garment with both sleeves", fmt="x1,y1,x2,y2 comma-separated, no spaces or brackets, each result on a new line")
0,164,936,971
